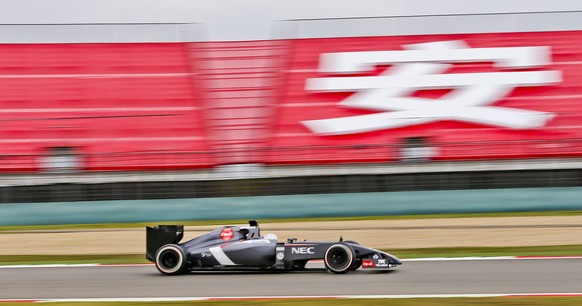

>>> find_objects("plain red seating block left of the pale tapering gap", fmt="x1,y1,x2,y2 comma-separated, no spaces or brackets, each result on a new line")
0,43,211,171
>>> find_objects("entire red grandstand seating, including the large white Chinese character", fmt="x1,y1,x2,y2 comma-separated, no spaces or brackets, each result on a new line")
0,31,582,172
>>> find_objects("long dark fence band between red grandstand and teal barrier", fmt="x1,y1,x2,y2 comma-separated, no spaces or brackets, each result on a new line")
0,164,582,203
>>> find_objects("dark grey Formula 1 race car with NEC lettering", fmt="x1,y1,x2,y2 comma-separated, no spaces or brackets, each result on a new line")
146,220,402,275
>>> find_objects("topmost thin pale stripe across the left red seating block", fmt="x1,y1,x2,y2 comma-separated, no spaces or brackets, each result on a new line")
0,72,193,79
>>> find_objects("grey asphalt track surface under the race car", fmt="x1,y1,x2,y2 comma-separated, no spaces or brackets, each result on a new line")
0,259,582,300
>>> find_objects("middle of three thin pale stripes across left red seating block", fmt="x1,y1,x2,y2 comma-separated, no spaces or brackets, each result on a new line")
0,106,200,114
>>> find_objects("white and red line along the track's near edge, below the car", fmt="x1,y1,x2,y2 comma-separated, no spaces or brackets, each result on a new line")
0,292,582,303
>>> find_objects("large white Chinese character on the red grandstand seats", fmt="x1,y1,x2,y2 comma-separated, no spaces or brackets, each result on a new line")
302,41,561,135
